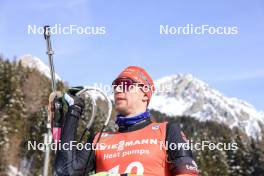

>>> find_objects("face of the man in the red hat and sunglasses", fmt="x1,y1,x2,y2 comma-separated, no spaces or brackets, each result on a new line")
114,78,148,116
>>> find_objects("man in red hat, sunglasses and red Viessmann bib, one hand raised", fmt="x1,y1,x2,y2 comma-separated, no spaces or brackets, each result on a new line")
51,66,198,176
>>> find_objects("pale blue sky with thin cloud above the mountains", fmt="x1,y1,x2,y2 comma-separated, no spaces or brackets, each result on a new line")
0,0,264,111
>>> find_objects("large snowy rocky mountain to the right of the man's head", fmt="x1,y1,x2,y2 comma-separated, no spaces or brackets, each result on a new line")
150,74,264,138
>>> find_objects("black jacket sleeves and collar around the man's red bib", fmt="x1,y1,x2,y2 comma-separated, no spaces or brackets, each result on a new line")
54,107,198,176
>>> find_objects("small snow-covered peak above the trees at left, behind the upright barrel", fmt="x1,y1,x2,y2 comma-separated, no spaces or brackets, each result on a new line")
18,54,61,80
